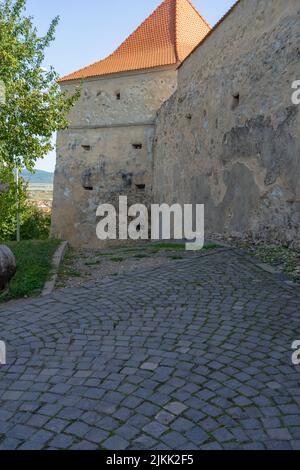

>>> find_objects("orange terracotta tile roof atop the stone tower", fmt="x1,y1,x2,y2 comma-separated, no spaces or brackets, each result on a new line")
60,0,211,81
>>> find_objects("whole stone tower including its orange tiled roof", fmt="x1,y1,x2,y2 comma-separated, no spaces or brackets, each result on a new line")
52,0,210,247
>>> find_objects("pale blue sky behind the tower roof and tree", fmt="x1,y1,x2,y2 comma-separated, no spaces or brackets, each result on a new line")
27,0,235,171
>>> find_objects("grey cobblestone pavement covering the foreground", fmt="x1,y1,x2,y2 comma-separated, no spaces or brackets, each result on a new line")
0,251,300,450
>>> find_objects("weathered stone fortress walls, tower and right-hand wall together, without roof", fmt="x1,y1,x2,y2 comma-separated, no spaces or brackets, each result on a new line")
52,0,300,247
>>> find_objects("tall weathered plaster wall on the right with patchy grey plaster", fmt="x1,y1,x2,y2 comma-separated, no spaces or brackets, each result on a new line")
154,0,300,248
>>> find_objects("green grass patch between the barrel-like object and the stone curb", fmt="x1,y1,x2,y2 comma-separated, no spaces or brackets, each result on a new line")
0,240,60,302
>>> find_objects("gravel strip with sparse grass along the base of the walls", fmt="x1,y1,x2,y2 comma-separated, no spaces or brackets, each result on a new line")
56,238,300,288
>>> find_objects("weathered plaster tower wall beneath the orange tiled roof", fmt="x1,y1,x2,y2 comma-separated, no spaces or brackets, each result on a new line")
52,68,177,247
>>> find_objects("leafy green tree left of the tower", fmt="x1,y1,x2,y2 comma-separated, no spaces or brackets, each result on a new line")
0,0,80,170
